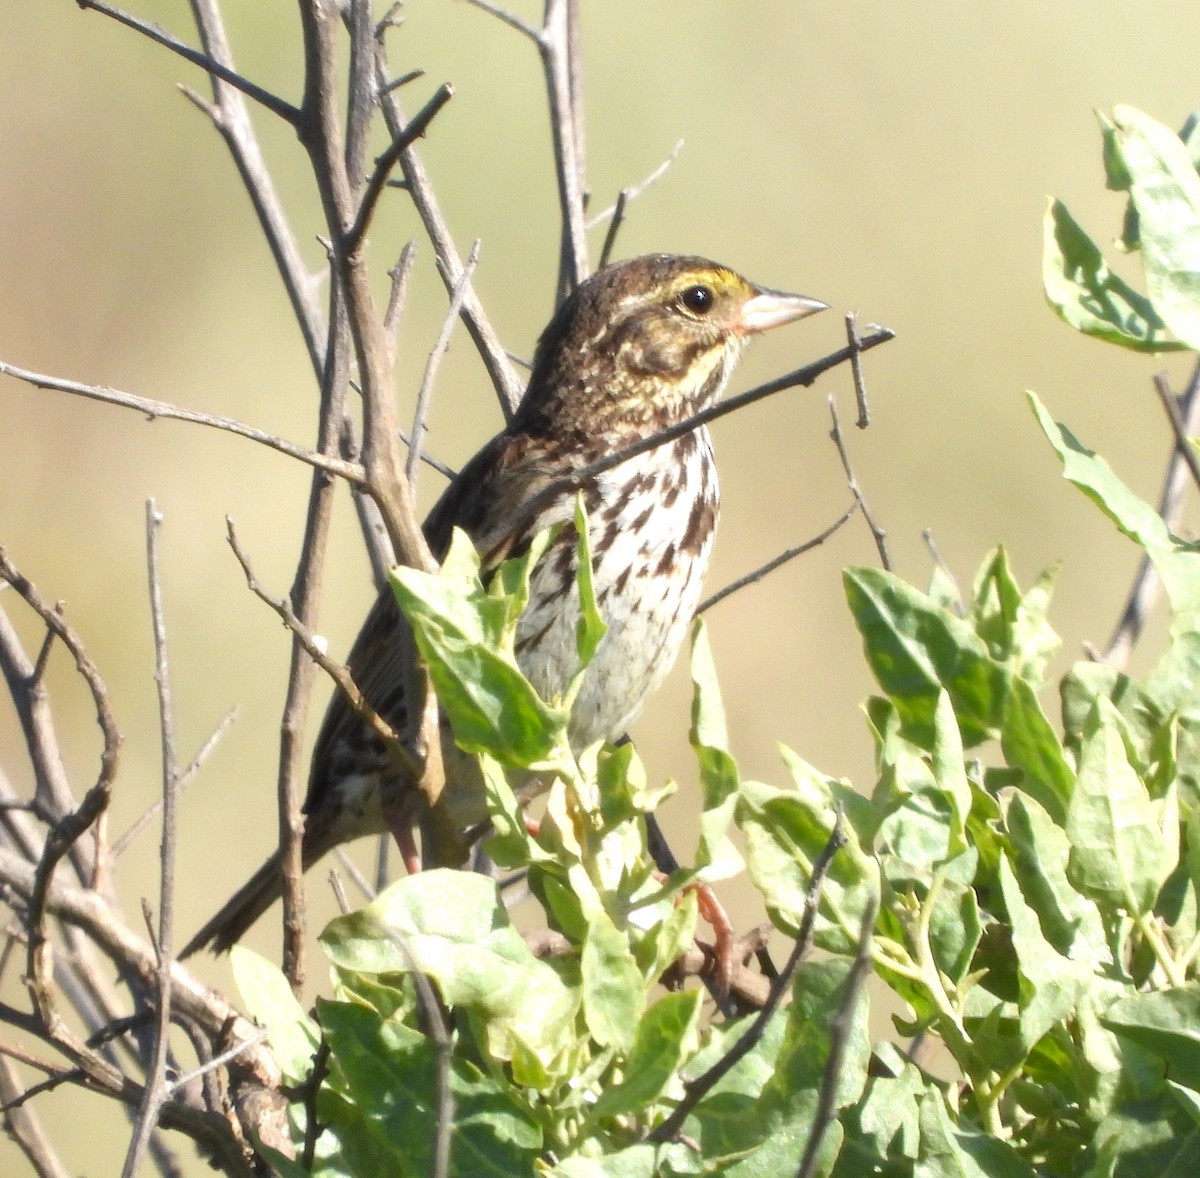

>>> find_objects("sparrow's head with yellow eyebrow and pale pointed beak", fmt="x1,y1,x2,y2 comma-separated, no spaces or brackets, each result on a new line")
514,254,826,435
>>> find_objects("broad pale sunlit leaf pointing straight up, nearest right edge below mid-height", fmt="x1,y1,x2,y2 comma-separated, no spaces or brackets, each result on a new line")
1067,699,1175,914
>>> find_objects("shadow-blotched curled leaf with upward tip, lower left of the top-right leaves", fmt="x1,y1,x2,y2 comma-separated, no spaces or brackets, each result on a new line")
1042,200,1188,353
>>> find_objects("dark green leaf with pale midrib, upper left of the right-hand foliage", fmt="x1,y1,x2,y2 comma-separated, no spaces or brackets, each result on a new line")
842,569,1009,749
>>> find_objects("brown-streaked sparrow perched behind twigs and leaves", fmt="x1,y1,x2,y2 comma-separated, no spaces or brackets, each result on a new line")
182,254,824,956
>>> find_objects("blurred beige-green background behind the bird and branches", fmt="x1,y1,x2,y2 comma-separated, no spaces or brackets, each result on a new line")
0,0,1200,1174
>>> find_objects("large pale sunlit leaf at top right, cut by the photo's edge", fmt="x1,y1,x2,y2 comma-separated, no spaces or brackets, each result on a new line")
1112,106,1200,348
